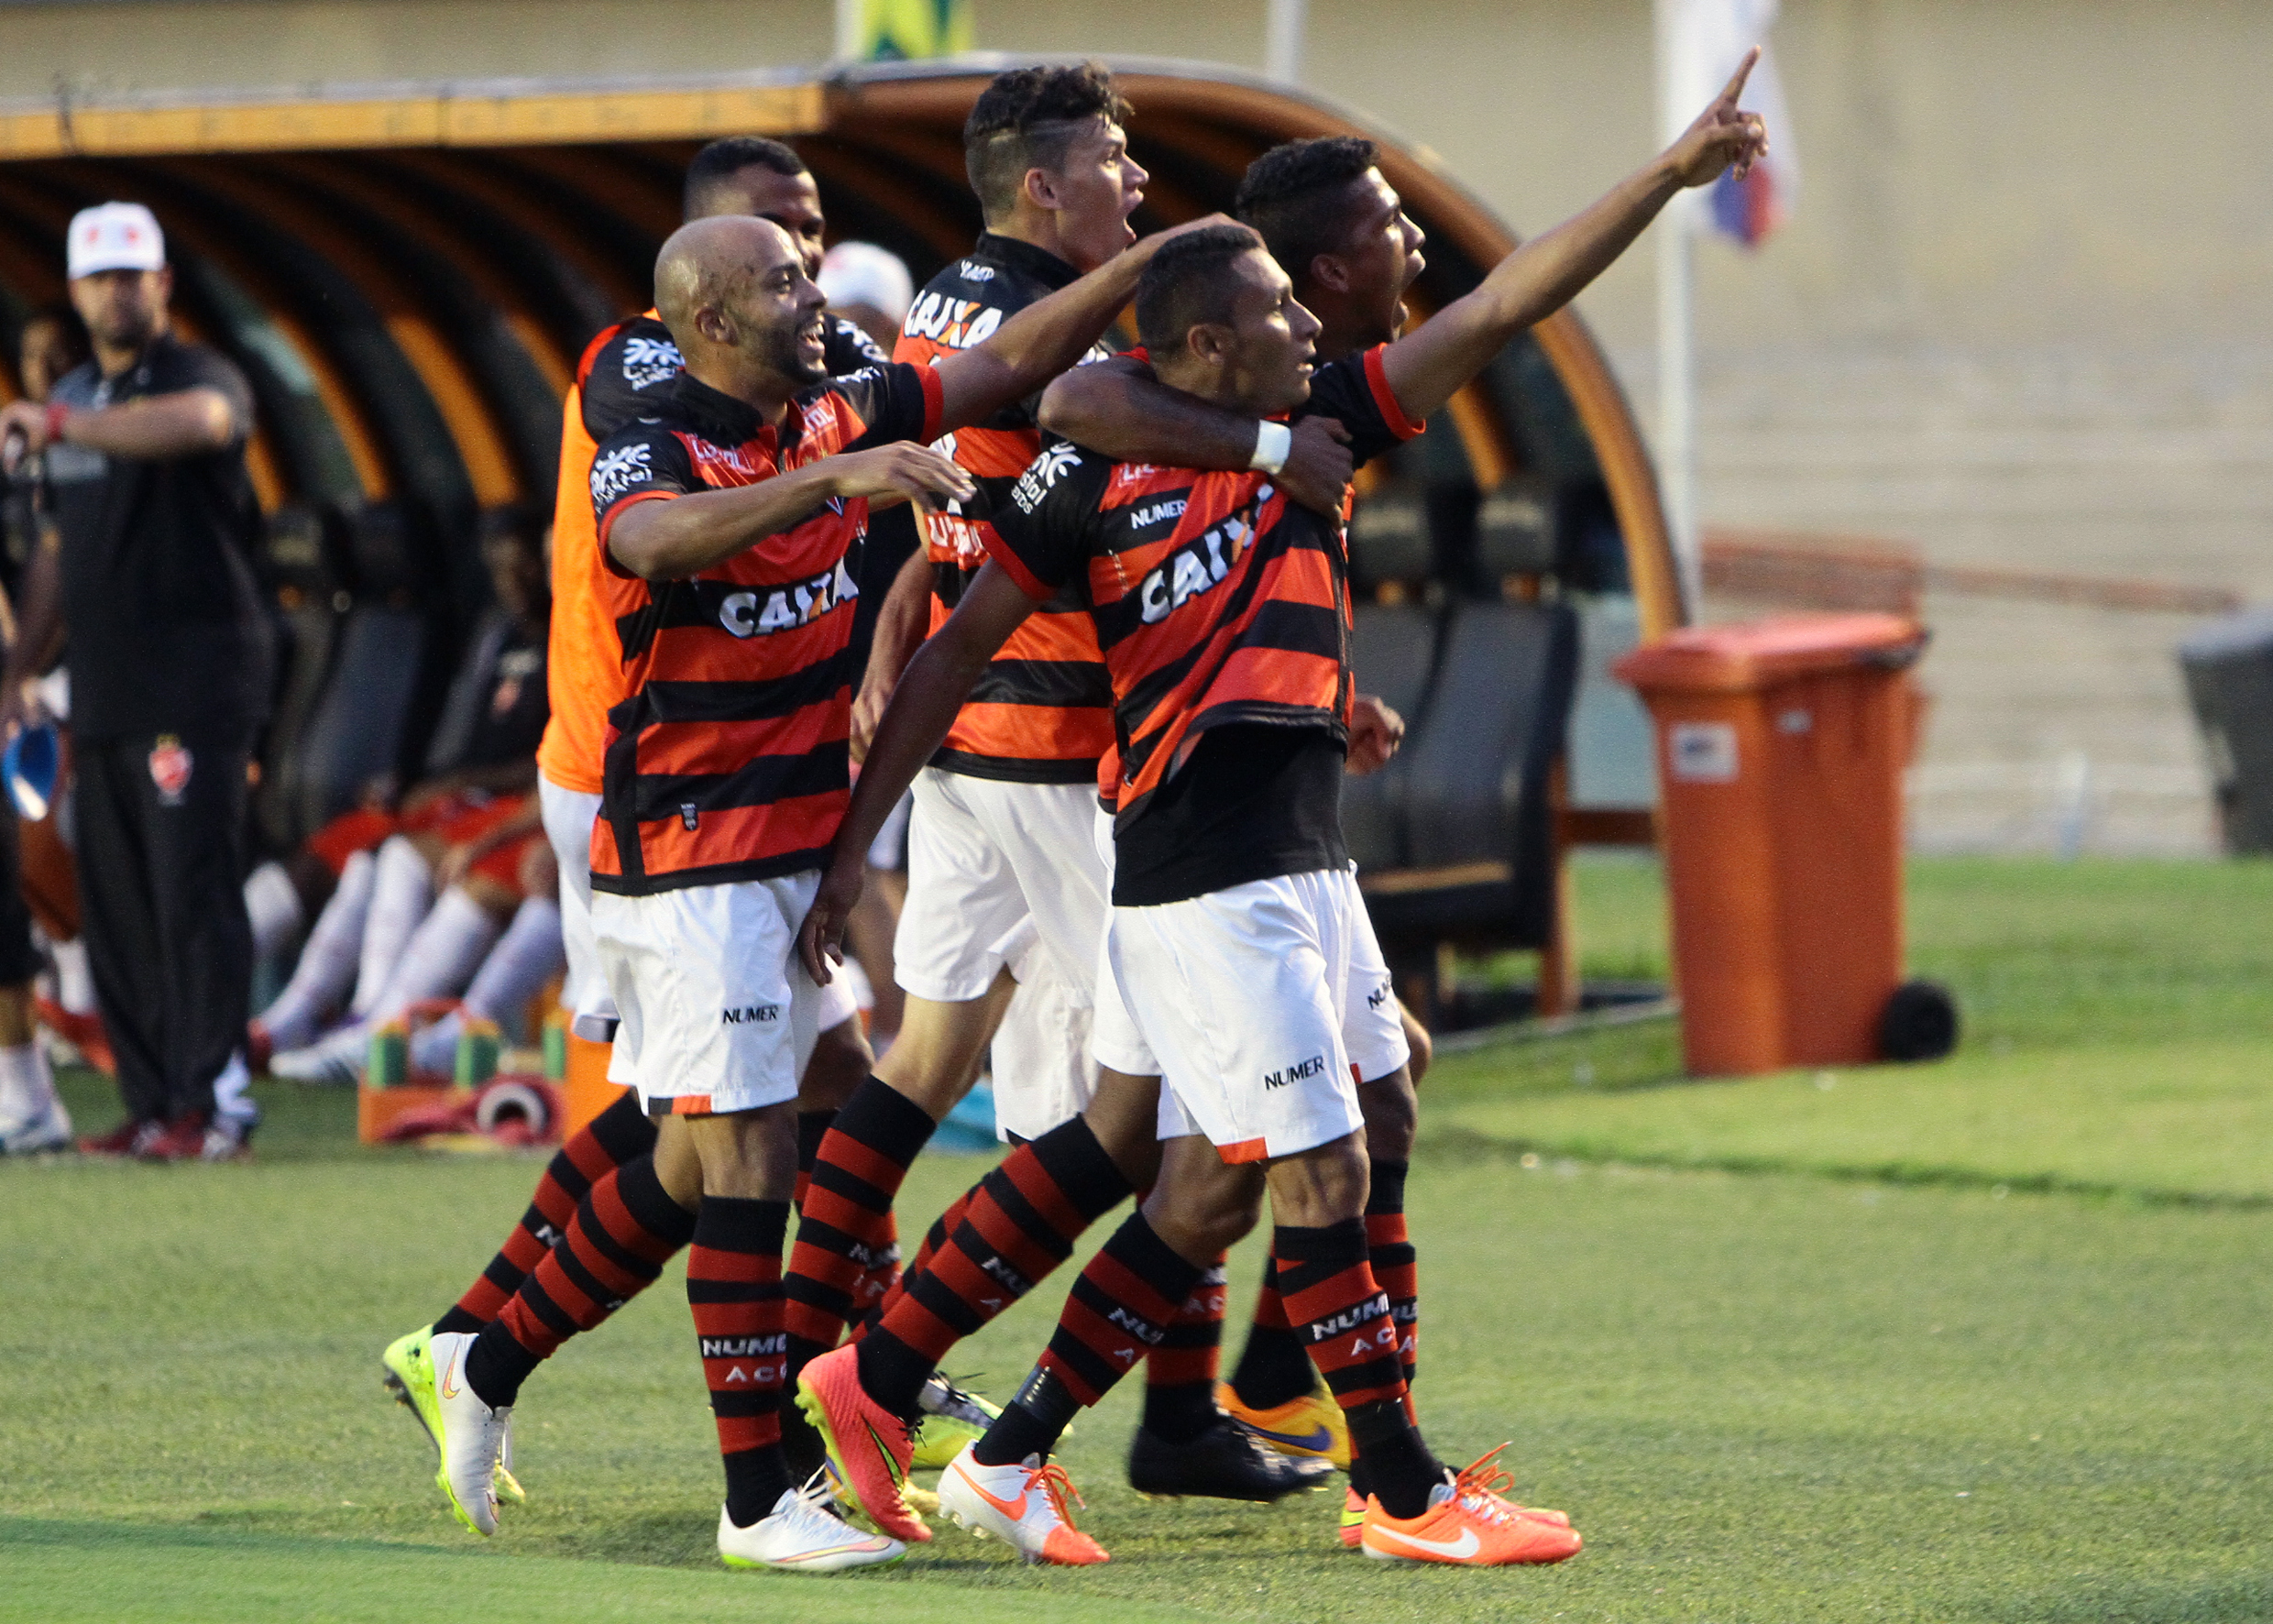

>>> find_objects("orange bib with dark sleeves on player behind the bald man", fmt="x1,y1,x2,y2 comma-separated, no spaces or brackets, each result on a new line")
536,312,891,795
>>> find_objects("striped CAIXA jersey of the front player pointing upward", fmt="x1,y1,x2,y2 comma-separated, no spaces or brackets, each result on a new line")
994,350,1421,906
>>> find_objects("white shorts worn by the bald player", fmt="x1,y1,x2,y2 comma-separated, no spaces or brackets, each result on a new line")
591,872,857,1115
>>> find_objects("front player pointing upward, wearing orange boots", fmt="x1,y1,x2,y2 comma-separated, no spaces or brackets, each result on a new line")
800,60,1766,1565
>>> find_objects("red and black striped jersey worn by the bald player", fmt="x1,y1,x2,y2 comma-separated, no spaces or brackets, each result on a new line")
591,364,941,894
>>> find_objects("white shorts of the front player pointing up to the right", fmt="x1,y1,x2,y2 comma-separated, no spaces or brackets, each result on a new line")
1107,868,1366,1163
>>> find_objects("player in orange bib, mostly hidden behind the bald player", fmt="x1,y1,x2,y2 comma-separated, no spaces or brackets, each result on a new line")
382,137,913,1499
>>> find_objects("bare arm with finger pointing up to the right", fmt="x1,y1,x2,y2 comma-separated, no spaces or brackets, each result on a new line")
1382,46,1768,420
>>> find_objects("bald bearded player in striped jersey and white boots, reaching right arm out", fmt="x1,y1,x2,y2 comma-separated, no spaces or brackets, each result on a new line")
432,206,1227,1572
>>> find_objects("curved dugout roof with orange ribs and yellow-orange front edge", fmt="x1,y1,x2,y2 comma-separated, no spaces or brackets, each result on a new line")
0,57,1680,636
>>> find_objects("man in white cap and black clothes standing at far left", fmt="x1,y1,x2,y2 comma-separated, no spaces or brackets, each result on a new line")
0,203,270,1160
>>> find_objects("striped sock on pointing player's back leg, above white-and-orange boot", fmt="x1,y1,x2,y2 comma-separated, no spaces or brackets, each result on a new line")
975,1211,1207,1465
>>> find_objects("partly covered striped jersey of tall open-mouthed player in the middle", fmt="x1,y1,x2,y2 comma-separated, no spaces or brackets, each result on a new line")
894,232,1114,784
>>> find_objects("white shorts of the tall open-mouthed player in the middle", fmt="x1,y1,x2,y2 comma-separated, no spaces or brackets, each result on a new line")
891,768,1107,1004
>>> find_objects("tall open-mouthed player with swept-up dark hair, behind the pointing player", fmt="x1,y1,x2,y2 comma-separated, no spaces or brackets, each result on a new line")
786,63,1345,1529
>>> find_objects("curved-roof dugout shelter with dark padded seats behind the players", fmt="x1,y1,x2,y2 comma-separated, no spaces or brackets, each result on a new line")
0,57,1682,1031
